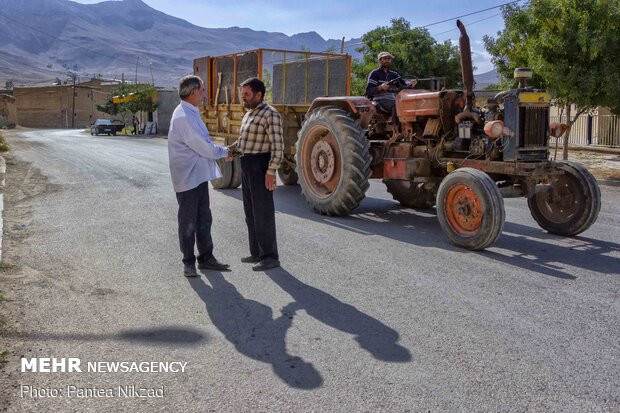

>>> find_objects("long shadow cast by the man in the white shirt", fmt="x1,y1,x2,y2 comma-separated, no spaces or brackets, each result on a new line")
188,271,323,389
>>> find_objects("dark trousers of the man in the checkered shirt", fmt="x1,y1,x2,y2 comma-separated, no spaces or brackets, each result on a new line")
241,153,279,260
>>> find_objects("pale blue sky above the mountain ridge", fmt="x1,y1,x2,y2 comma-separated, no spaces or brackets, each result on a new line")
74,0,510,73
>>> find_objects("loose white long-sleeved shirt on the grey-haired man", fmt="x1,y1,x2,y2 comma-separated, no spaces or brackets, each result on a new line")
168,100,228,192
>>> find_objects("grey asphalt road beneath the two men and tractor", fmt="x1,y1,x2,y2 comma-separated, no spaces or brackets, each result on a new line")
2,130,620,412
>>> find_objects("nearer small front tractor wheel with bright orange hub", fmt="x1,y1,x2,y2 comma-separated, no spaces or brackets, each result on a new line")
437,168,505,250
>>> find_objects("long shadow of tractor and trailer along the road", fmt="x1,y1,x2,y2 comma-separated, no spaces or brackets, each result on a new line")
219,186,620,279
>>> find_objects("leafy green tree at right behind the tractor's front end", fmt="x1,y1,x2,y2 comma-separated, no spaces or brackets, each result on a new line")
484,0,620,159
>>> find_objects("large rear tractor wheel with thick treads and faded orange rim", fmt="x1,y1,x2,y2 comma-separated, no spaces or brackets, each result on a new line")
297,106,371,215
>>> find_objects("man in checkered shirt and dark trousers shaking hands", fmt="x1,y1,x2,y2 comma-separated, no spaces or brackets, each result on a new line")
231,78,284,271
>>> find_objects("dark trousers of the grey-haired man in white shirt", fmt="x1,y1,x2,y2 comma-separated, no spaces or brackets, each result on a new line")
177,182,213,265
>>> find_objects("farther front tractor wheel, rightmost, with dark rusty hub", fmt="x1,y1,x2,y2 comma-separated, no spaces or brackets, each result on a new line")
527,161,601,236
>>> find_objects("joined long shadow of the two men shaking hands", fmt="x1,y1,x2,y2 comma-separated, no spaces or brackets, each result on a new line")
188,268,411,389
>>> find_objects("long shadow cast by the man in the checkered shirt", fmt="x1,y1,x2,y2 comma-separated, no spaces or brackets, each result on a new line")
266,268,411,363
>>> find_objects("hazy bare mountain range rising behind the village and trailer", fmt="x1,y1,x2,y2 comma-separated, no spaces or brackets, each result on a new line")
0,0,359,86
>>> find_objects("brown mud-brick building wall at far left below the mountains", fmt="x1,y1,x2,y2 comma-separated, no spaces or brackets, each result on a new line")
13,79,118,128
